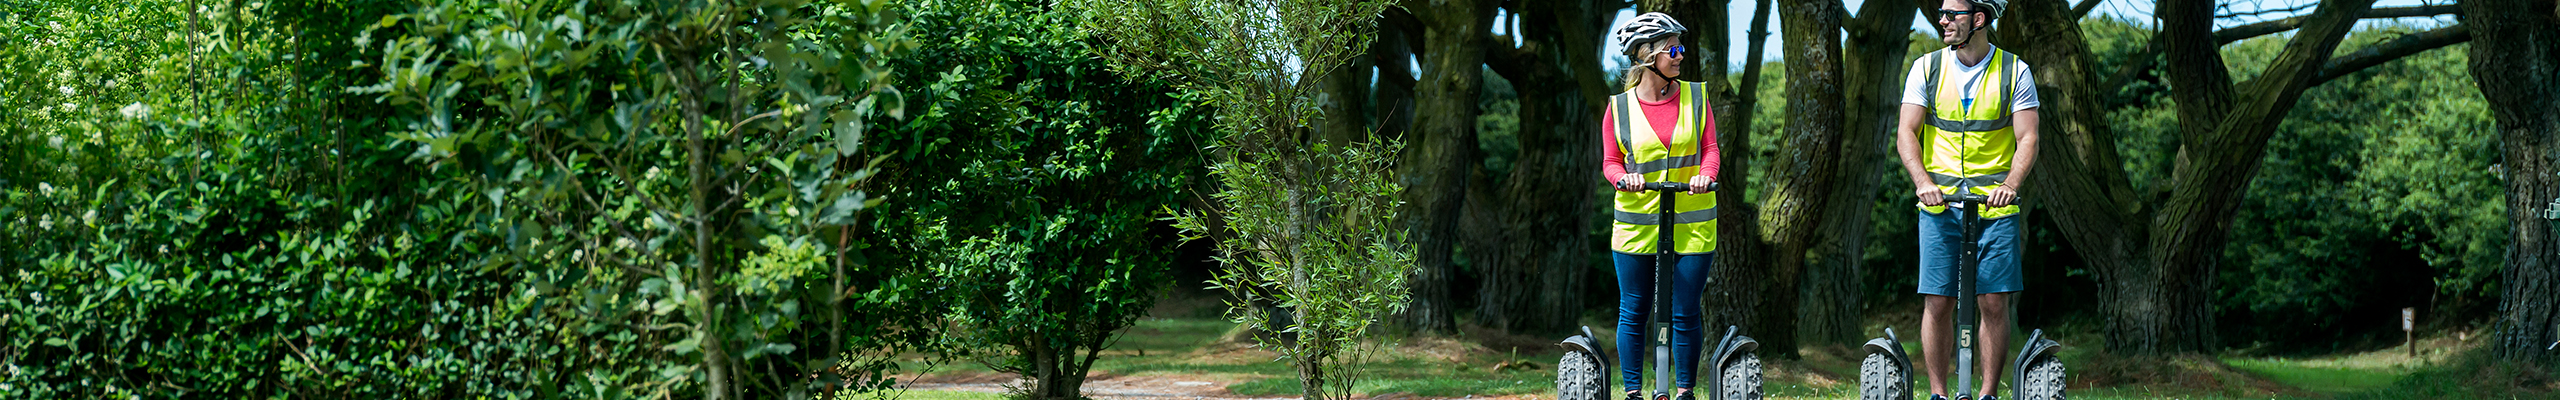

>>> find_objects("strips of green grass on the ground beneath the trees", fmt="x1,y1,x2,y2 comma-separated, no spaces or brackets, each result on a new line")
896,318,2560,400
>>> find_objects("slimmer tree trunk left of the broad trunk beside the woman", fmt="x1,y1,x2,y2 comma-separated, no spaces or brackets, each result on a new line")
1398,0,1492,333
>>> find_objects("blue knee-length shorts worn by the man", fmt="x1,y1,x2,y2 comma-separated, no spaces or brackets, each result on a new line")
1912,208,2028,297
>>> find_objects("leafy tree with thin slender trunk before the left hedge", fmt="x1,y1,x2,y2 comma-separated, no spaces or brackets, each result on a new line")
348,0,911,397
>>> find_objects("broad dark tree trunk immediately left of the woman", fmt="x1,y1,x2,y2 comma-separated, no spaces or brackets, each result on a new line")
1467,0,1613,333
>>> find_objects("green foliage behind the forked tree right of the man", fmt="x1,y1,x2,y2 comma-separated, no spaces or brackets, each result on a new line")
2081,18,2506,351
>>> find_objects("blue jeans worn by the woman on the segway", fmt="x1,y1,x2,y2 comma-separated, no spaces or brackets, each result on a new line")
1610,251,1715,390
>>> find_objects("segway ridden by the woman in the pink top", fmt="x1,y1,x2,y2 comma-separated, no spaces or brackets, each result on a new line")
1556,182,1761,400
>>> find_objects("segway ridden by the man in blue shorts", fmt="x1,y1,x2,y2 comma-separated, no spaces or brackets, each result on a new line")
1859,187,2063,400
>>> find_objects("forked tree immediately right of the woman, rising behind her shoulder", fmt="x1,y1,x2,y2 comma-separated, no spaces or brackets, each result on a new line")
1656,0,1846,356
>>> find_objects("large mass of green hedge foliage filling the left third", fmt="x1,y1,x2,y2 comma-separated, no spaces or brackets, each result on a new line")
0,0,924,397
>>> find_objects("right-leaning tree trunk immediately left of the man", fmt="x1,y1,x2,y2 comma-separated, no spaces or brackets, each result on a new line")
1800,0,1920,346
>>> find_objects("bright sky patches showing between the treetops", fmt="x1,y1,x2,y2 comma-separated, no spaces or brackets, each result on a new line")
1492,0,2452,69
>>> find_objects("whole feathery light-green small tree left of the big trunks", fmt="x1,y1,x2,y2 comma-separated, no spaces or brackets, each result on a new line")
1062,0,1413,400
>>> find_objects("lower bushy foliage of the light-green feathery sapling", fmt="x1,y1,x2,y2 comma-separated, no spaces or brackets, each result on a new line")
1175,144,1413,397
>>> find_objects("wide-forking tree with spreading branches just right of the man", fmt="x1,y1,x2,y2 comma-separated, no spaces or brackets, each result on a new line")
1994,0,2450,354
